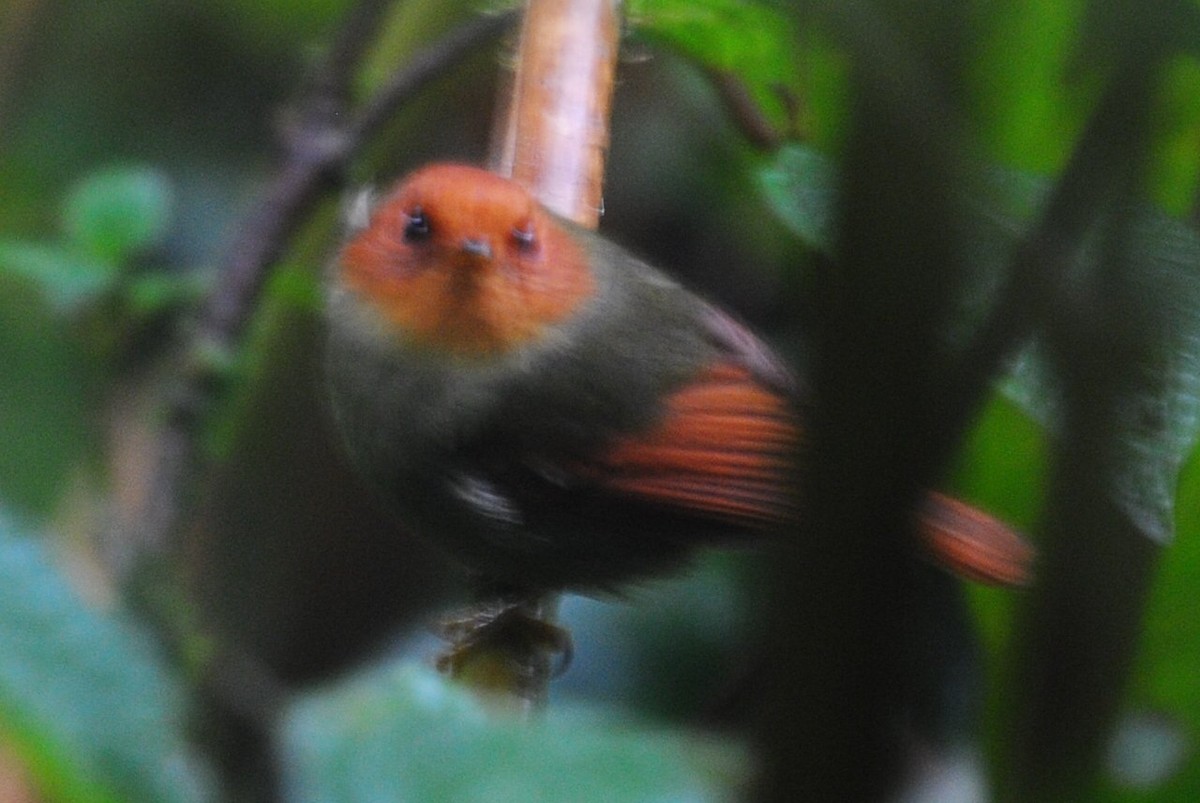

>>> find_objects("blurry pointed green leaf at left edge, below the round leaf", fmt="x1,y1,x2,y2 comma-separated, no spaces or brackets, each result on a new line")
0,240,115,312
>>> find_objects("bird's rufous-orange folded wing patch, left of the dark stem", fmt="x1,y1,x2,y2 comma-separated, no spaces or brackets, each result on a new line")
582,364,800,528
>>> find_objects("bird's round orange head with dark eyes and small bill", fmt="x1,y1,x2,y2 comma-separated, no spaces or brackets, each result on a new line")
338,164,594,356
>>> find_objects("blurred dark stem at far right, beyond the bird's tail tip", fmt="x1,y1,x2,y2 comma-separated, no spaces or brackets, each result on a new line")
1002,48,1168,802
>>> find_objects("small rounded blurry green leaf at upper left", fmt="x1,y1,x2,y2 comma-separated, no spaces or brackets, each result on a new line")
62,167,172,264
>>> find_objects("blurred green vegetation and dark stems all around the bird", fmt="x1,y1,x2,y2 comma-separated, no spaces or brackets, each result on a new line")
0,0,1200,802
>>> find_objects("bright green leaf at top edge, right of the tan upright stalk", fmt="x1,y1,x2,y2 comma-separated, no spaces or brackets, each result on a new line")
626,0,800,133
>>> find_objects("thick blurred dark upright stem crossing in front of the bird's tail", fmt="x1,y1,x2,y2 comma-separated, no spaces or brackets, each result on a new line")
761,7,961,801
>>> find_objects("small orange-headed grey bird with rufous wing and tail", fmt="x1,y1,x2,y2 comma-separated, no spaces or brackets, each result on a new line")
328,163,1031,592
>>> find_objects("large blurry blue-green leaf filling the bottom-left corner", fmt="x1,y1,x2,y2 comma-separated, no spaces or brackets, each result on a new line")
0,516,209,803
